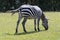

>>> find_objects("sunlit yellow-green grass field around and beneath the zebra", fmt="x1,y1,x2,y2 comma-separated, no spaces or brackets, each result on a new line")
0,12,60,40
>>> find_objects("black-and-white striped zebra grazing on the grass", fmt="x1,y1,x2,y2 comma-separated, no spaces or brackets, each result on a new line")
11,4,48,33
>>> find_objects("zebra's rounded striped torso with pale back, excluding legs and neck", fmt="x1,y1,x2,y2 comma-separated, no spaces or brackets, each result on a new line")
20,5,42,18
